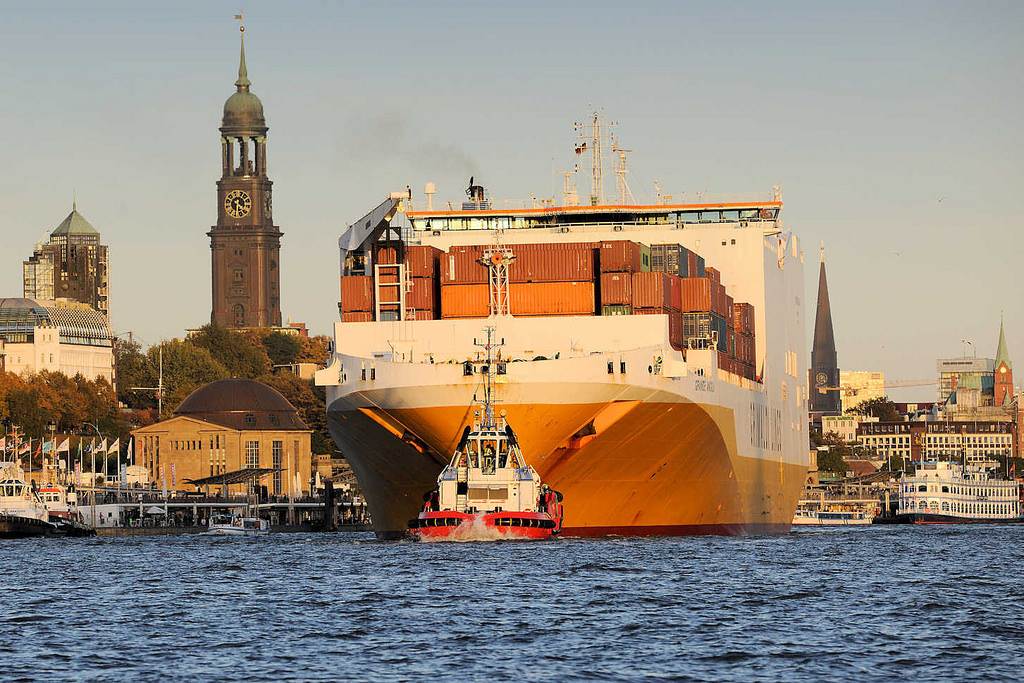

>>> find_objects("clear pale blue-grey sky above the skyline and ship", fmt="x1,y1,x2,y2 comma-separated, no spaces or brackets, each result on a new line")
0,1,1024,399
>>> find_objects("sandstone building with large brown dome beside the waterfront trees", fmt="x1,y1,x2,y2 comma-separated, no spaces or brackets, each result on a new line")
132,379,312,496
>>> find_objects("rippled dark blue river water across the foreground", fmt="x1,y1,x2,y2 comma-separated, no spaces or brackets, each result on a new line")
0,525,1024,681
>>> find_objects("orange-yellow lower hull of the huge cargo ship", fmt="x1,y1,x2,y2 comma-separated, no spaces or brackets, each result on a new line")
328,395,807,537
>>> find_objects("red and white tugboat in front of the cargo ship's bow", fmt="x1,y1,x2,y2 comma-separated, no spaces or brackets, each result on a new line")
409,327,562,541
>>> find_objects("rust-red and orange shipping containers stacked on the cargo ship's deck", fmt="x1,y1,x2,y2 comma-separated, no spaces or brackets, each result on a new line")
340,240,754,378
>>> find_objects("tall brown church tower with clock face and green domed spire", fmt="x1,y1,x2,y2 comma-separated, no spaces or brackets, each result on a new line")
207,26,282,328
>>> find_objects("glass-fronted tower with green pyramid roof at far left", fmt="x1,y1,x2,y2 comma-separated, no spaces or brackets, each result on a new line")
22,202,111,319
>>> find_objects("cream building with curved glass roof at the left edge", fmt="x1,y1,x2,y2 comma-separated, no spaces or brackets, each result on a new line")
0,298,115,384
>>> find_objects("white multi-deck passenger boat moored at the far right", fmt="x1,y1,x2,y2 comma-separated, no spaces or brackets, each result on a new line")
896,462,1024,523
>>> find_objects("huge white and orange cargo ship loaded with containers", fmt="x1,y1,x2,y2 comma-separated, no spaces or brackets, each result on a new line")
316,116,808,537
